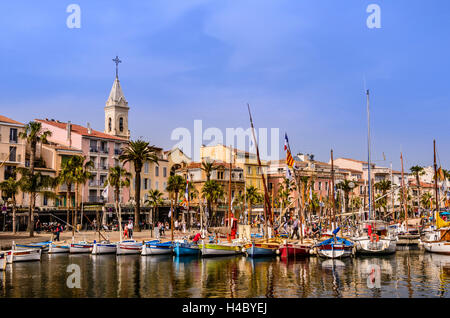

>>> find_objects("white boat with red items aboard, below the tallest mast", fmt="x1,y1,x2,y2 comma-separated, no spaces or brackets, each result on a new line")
352,220,397,255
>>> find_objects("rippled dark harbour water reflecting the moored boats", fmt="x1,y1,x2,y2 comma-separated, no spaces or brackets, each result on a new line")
0,250,450,298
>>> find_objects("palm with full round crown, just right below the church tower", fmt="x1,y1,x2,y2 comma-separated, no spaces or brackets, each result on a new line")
119,139,158,232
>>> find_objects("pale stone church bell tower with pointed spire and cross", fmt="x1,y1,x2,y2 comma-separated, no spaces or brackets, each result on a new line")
105,56,130,139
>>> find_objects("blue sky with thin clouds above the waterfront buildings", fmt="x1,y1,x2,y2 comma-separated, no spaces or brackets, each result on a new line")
0,0,450,169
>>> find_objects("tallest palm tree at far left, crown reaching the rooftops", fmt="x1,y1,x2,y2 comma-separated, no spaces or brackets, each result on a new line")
19,121,52,237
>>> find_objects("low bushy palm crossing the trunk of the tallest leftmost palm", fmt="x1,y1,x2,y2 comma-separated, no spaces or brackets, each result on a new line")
18,168,57,237
